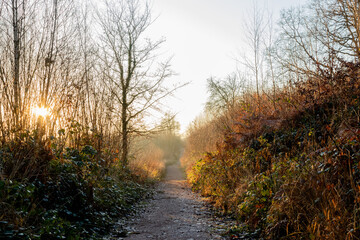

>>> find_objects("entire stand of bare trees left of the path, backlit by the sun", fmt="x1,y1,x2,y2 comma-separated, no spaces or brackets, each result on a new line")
0,0,179,159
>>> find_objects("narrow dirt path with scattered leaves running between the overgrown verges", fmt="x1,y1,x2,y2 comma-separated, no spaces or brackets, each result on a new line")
126,165,222,240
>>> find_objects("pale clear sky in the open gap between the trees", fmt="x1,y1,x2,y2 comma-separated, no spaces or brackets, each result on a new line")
149,0,304,132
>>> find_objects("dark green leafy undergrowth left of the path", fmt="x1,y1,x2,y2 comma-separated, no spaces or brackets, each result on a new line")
0,132,150,239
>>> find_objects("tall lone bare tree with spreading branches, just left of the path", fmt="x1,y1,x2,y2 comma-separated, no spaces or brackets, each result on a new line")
97,0,177,166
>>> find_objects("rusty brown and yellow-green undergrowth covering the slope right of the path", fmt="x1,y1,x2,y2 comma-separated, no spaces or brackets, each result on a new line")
182,63,360,239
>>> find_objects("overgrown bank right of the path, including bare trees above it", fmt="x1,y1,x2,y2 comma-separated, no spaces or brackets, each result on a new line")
182,0,360,239
